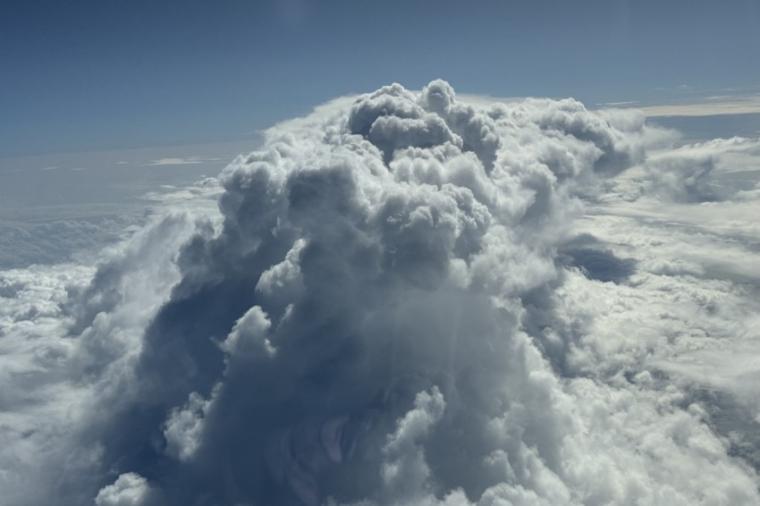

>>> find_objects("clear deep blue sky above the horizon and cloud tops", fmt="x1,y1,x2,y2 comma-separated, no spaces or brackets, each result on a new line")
0,0,760,155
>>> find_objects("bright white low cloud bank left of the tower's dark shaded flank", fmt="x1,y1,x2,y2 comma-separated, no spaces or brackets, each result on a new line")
0,188,213,505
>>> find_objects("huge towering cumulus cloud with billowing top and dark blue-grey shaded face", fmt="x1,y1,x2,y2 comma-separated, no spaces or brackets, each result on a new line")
4,81,760,506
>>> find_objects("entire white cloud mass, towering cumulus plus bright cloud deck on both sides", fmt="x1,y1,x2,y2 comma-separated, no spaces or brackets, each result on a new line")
0,81,760,506
